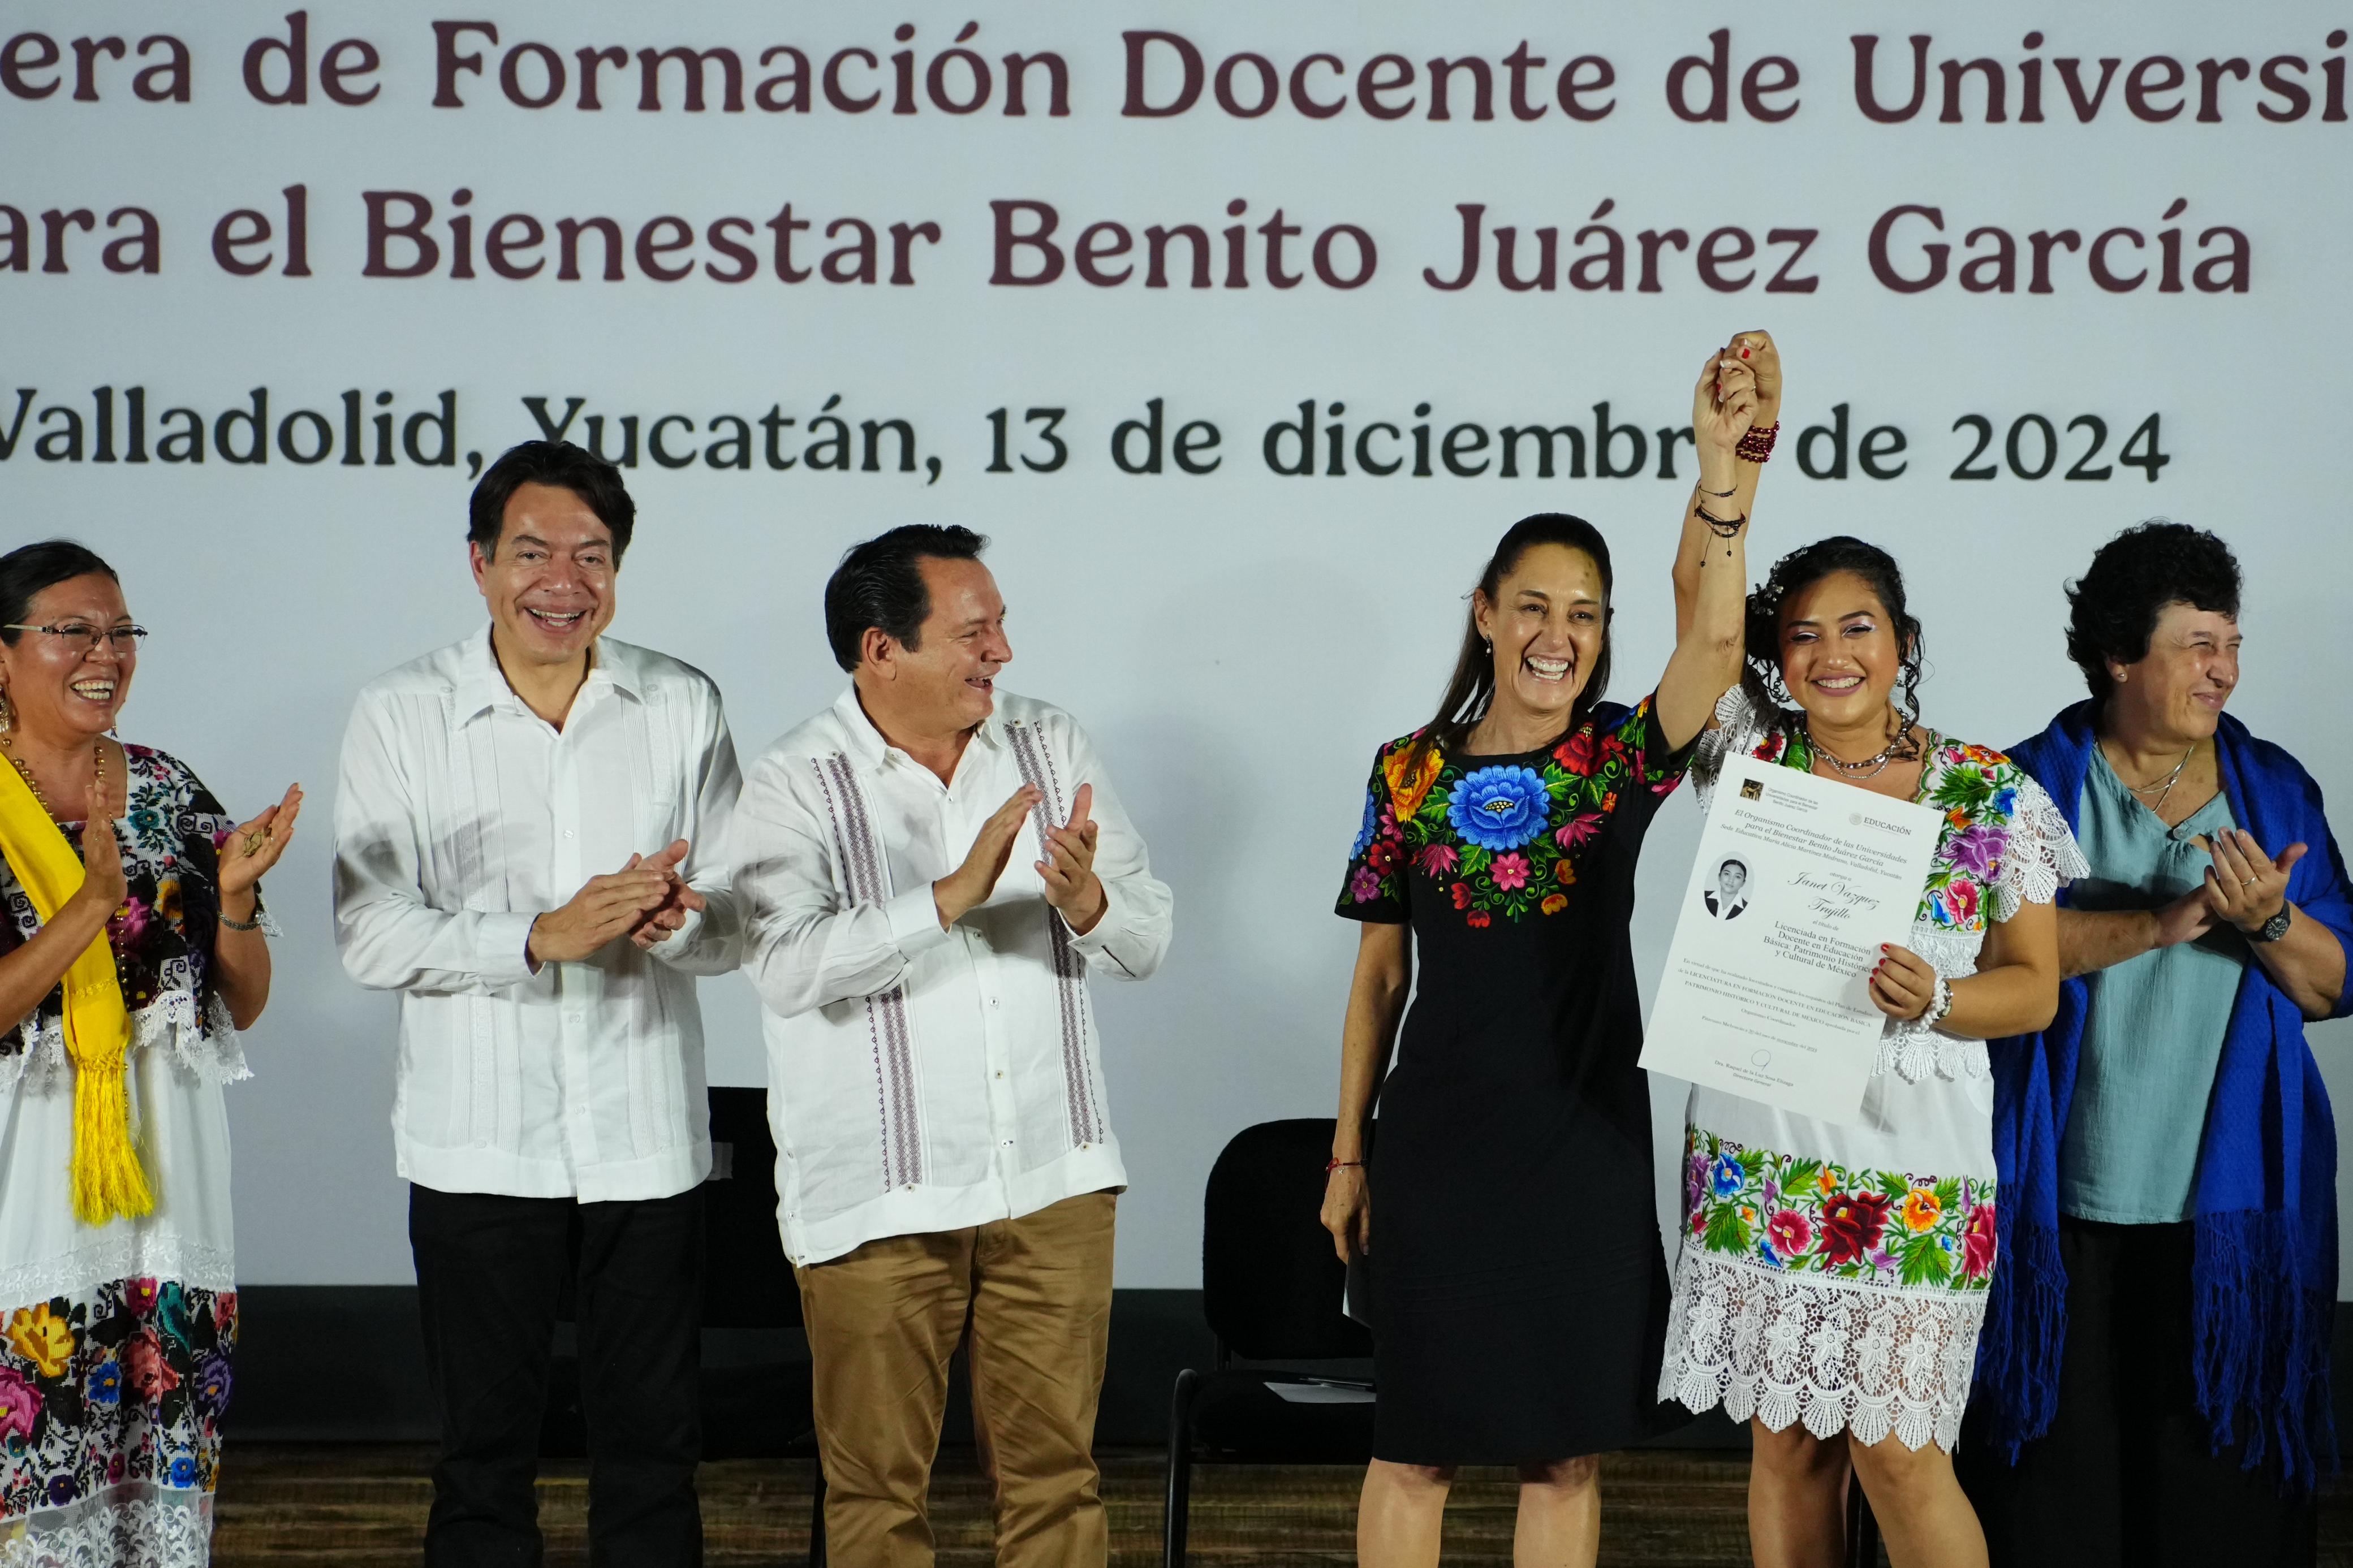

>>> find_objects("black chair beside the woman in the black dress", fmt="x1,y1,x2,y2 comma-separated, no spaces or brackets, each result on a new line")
1160,1117,1372,1568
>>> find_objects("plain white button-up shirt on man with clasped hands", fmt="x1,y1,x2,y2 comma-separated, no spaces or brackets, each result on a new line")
334,628,741,1201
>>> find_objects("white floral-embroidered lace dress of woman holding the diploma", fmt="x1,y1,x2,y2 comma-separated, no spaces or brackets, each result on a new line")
1659,686,2087,1450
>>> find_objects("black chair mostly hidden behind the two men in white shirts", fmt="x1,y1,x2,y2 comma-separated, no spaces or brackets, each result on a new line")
539,1088,826,1568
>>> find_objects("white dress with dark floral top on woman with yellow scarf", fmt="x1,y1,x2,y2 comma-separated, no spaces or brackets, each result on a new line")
0,745,247,1568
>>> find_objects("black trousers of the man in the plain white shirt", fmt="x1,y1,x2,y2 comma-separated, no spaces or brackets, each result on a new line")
410,1185,704,1568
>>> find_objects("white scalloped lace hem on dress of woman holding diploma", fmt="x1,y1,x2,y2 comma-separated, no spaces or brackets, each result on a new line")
1659,1249,1986,1453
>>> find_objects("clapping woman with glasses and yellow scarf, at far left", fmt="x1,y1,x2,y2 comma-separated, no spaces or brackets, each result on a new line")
0,541,301,1568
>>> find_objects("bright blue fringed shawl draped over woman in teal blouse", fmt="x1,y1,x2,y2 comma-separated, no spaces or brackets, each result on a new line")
1974,703,2353,1491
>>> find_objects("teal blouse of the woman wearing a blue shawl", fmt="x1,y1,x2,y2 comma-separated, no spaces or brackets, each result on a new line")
2059,745,2247,1225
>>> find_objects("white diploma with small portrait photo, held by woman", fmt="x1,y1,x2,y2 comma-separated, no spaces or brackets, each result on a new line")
1643,757,1943,1121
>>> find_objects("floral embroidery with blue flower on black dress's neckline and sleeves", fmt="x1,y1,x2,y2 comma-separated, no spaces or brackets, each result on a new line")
1341,701,1682,926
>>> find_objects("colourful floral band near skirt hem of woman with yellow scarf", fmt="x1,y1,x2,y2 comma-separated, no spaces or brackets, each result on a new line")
0,1279,238,1528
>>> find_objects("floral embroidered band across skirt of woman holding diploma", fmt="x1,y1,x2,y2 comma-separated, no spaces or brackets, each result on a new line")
1682,1126,1996,1290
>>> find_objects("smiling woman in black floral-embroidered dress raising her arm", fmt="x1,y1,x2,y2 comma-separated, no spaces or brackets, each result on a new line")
1322,331,1781,1568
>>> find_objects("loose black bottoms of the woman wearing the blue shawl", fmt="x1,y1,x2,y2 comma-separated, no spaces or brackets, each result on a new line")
1960,1218,2320,1568
